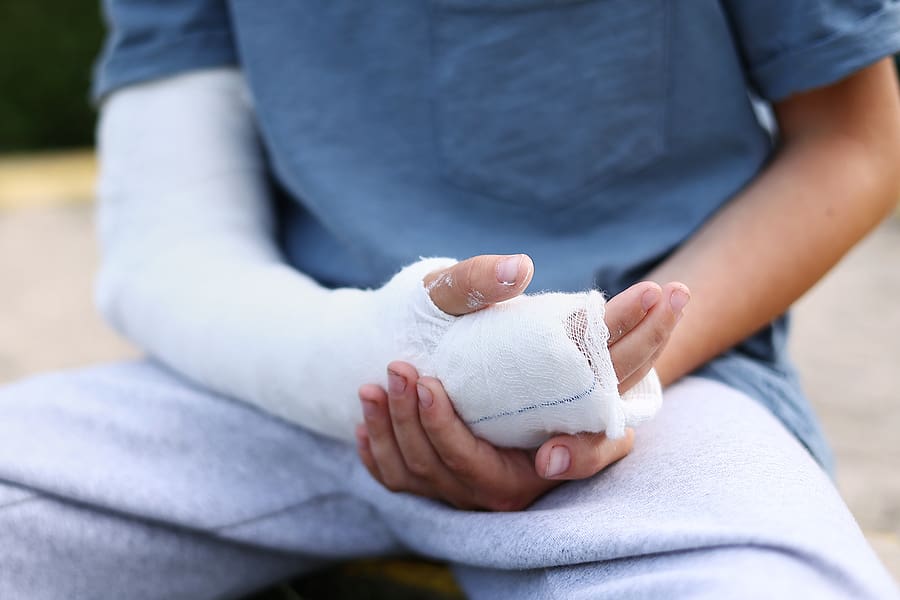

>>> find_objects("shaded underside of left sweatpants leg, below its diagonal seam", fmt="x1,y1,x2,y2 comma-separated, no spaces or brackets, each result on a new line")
0,483,316,600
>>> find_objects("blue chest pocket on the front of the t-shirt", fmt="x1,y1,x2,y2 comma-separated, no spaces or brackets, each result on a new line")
432,0,668,208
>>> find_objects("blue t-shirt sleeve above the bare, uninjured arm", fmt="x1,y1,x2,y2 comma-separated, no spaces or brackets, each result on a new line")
724,0,900,101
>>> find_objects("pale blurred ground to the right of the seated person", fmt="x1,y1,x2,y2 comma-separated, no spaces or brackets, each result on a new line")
793,213,900,581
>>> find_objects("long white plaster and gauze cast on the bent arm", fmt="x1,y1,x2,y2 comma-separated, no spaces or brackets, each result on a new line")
97,69,659,446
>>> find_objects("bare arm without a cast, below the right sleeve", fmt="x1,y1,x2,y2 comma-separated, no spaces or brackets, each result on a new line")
650,61,898,384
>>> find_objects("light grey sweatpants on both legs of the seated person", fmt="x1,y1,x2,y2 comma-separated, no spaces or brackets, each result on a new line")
0,363,897,600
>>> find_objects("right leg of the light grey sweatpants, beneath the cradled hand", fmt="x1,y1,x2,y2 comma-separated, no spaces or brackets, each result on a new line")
354,378,896,598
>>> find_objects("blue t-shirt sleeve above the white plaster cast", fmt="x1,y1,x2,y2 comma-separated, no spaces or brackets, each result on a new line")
92,0,237,101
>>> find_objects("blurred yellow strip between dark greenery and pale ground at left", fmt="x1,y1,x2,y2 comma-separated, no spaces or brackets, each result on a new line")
0,149,97,210
